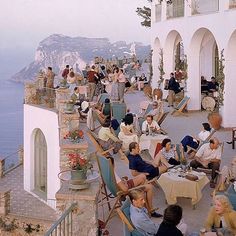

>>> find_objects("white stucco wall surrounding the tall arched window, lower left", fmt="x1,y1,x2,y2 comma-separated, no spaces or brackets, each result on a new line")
24,104,60,208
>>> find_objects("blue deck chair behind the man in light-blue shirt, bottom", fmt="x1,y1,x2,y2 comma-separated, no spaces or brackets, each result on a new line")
116,197,142,236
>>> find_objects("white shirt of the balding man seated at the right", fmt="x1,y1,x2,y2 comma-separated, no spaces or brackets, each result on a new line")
196,143,221,160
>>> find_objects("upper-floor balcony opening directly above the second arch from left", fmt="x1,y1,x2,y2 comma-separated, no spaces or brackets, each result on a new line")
166,0,185,19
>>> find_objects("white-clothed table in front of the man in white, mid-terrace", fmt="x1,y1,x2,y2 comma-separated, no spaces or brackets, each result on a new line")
139,134,168,159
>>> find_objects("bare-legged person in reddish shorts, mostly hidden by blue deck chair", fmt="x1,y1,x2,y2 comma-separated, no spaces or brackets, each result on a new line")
108,157,161,217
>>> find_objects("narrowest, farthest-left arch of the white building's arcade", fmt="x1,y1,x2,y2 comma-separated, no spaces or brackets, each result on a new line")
151,38,161,89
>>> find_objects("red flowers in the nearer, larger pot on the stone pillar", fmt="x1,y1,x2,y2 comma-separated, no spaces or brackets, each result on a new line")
68,153,92,170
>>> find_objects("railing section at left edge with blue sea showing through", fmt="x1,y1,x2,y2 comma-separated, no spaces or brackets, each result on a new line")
0,147,23,177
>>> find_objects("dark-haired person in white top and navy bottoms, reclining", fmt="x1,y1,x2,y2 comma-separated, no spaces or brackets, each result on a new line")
181,123,211,152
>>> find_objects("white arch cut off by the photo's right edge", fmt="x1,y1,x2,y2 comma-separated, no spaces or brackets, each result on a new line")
223,30,236,127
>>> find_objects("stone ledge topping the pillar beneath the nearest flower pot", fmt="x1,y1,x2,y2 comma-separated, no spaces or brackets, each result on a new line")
56,181,100,201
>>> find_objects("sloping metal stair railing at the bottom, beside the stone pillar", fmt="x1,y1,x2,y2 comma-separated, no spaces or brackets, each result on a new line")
45,203,77,236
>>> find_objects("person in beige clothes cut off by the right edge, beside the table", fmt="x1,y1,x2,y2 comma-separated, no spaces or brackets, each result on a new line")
216,157,236,191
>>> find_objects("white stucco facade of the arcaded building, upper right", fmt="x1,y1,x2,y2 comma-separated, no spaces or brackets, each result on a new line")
151,0,236,127
